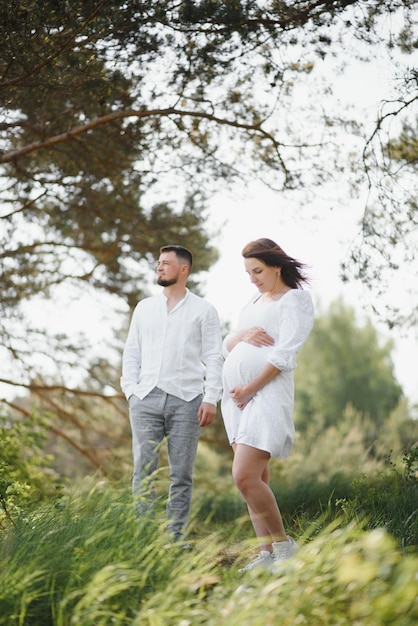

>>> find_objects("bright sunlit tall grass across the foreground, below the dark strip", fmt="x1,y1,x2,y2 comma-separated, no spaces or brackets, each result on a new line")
0,470,418,626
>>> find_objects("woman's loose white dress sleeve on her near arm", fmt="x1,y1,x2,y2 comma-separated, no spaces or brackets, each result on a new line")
267,289,314,371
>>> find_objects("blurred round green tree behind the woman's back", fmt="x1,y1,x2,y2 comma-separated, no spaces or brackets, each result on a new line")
295,301,402,429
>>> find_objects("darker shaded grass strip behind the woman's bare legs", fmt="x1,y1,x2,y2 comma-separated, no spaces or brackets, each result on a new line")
195,446,418,550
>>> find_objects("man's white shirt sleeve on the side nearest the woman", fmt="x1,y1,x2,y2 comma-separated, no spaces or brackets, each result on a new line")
202,305,223,405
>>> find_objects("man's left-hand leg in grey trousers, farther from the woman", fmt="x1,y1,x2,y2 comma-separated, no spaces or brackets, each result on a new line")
129,389,167,514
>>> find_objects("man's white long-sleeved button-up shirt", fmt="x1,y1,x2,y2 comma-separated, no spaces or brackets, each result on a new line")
121,289,223,404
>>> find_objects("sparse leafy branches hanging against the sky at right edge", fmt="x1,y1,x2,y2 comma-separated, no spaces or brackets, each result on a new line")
342,77,418,328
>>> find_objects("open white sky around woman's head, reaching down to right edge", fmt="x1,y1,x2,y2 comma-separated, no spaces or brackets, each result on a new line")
205,180,418,402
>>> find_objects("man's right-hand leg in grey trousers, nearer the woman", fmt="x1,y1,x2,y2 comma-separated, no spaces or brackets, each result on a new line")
166,395,202,540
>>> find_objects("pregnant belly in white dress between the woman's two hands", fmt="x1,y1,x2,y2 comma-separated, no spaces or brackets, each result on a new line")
224,341,271,388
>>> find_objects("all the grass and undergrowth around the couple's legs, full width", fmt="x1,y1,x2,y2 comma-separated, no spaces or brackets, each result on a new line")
0,404,418,626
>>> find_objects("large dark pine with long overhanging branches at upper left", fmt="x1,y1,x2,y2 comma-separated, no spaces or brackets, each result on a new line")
0,0,416,466
